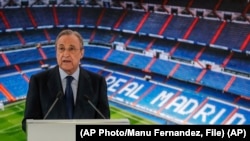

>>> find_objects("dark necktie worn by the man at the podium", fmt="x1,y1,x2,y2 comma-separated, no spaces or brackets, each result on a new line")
65,76,74,119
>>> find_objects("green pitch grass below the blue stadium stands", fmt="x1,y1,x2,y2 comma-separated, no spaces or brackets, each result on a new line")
0,100,155,141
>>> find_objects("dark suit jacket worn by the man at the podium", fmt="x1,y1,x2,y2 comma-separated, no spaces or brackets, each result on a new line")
22,66,110,131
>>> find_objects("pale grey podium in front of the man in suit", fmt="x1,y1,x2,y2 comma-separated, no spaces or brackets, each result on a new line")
26,119,130,141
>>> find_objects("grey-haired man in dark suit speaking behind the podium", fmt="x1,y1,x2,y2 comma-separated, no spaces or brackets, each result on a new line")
22,29,110,132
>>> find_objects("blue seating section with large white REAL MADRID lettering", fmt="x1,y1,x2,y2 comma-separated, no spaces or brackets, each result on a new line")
106,72,250,125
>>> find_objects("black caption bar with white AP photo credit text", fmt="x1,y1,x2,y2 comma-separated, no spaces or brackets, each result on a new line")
76,125,250,141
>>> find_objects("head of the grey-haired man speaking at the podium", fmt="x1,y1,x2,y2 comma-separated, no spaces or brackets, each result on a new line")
55,29,84,75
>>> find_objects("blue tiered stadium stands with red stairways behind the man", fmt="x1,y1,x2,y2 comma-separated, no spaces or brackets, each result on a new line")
0,0,250,124
